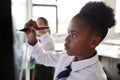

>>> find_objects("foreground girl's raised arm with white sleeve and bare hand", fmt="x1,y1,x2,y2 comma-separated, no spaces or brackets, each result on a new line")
24,20,61,67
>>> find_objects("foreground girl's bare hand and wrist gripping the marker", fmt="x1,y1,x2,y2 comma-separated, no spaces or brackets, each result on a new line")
24,19,37,46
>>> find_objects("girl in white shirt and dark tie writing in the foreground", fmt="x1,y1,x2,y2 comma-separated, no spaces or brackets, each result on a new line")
25,2,115,80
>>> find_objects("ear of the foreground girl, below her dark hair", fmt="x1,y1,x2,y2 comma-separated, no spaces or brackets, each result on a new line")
90,36,101,48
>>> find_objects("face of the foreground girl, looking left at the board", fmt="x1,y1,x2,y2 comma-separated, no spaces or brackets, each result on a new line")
65,19,94,57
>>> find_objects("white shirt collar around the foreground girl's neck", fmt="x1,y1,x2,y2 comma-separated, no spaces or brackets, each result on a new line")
71,54,98,71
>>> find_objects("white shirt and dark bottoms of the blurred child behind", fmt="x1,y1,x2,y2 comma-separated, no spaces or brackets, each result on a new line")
31,33,55,80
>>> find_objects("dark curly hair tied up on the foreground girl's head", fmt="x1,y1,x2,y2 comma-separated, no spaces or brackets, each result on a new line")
73,2,115,40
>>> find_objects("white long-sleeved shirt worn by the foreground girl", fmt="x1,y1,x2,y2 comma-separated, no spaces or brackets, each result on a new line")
28,42,107,80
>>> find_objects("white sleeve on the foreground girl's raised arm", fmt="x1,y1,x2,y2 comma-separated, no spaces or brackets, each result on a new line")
28,42,61,67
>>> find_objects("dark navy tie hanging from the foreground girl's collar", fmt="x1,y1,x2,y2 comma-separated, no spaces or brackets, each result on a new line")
56,64,72,80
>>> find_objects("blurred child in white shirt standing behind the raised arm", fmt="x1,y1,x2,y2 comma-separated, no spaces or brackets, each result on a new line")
32,17,55,80
